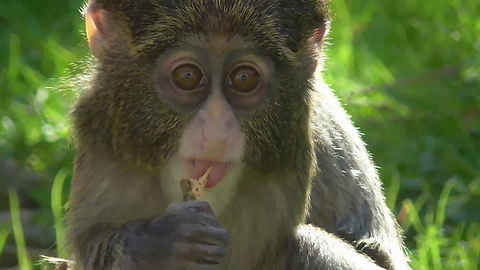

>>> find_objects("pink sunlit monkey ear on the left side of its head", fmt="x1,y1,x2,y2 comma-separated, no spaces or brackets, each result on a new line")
85,2,118,58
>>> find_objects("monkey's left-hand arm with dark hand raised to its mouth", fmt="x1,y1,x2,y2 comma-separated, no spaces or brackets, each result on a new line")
67,150,229,270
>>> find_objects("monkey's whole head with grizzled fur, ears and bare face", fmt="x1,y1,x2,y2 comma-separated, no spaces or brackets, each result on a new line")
73,0,328,187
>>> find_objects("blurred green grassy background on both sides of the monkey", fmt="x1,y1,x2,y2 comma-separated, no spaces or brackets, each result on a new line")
0,0,480,270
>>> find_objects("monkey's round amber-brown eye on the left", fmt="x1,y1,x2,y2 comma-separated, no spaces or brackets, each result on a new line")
172,64,203,91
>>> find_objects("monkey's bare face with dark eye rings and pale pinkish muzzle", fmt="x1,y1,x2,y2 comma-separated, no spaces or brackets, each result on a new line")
154,35,275,188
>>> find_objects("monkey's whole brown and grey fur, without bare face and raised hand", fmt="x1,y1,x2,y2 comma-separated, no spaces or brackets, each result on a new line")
67,0,408,270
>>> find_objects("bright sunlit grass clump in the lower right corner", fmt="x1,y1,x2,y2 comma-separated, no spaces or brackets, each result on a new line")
403,181,480,270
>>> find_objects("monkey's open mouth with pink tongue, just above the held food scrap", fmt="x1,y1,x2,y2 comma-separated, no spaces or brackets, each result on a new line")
187,159,231,188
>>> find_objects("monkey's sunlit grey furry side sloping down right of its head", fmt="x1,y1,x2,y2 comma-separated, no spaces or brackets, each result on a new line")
308,86,409,269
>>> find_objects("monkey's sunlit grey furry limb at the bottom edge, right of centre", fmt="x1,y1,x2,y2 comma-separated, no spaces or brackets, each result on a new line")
285,225,382,270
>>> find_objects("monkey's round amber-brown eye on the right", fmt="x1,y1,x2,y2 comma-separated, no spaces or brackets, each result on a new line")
229,66,261,93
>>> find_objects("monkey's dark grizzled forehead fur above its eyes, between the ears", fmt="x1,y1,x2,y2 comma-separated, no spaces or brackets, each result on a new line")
97,0,328,57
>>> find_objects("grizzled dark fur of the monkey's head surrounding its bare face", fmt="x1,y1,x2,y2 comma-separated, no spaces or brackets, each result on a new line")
73,0,328,170
